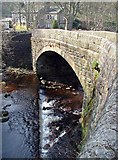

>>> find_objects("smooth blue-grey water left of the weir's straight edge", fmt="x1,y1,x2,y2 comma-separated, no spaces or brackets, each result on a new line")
1,74,40,158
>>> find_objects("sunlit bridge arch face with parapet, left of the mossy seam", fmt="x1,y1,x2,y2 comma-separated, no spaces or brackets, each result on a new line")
32,29,116,97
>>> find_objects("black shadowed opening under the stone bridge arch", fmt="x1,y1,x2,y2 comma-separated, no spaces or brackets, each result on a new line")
36,51,83,91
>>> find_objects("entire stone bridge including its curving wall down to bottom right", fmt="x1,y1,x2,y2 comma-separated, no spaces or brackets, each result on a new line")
32,29,117,158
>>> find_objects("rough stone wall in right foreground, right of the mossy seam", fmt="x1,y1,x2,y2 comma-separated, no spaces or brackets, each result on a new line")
78,33,118,159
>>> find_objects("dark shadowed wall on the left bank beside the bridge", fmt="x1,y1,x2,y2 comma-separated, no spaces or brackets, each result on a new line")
2,32,32,69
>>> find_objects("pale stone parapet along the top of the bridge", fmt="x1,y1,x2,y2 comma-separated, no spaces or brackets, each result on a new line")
32,29,117,46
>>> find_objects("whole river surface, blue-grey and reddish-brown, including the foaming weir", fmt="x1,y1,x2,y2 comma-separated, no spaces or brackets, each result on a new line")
0,76,83,158
